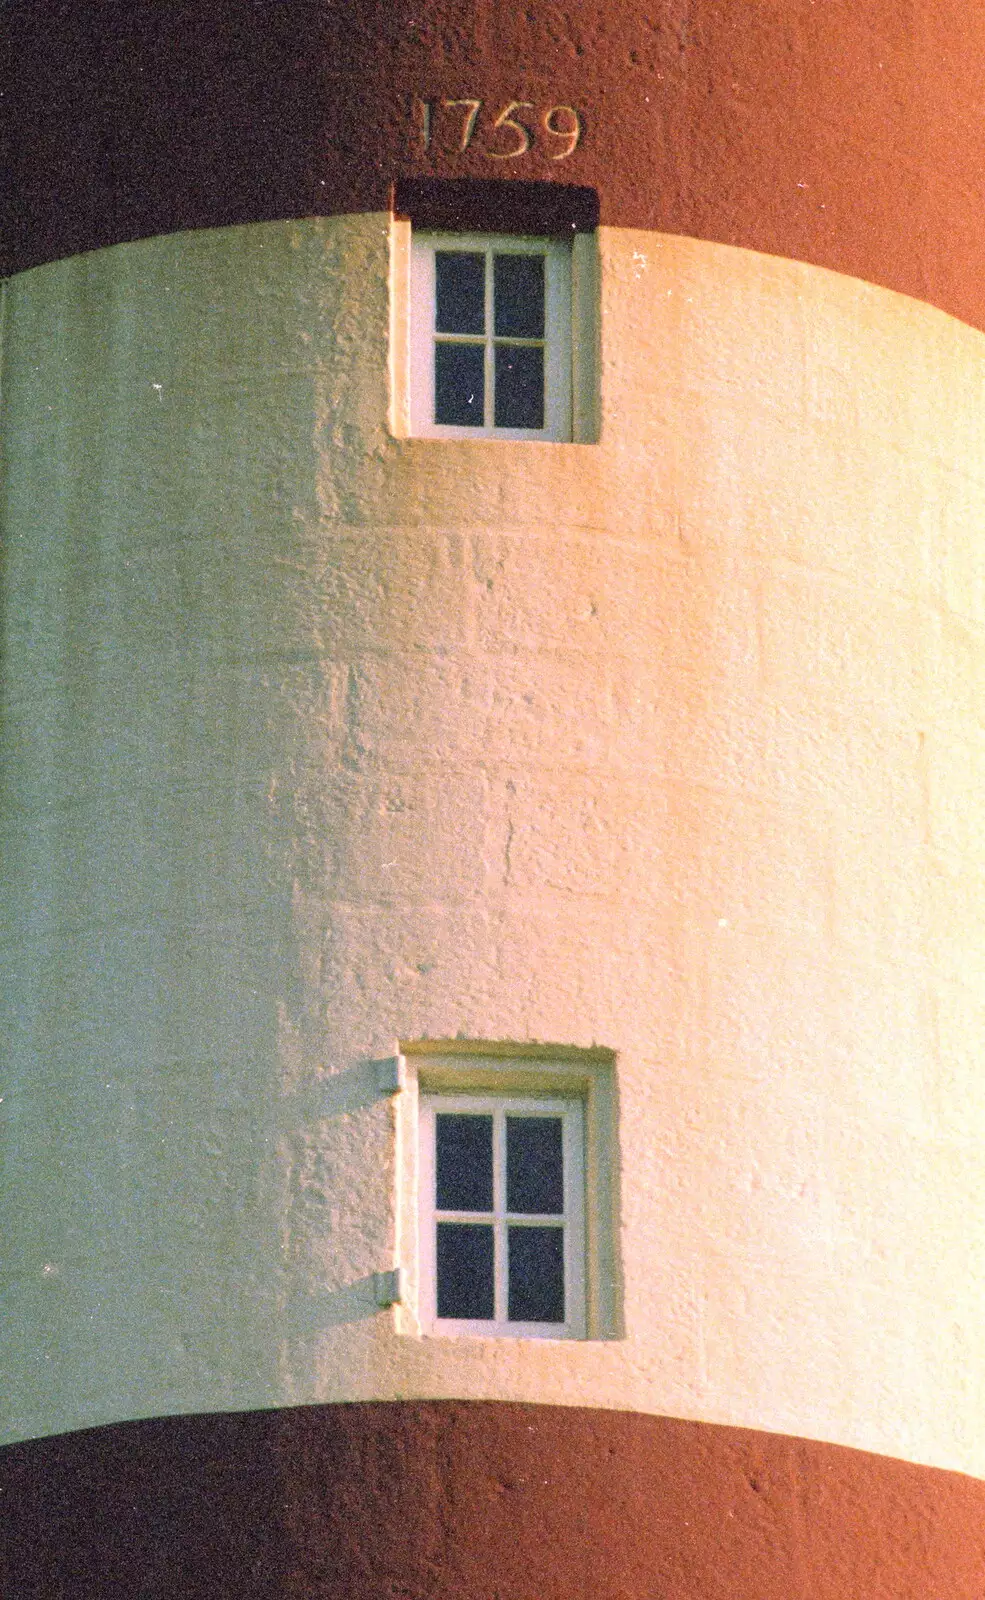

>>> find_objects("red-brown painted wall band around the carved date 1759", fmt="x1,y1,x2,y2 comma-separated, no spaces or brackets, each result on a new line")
0,0,985,326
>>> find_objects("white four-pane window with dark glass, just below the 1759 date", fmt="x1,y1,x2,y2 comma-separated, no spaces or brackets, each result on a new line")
411,232,571,440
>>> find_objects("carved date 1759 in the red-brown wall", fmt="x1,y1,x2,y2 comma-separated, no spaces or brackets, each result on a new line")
413,98,582,162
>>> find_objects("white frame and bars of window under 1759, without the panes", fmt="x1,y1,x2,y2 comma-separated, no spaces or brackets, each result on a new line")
409,230,572,440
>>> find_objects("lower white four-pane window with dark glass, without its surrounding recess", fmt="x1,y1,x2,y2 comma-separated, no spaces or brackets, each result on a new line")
421,1094,585,1339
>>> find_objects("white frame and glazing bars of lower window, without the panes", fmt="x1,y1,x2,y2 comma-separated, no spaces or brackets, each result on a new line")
419,1094,585,1339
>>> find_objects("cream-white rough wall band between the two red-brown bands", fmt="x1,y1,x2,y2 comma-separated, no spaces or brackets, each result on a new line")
0,216,985,1475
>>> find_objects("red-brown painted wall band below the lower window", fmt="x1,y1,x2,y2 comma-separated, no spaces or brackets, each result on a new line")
0,1400,985,1600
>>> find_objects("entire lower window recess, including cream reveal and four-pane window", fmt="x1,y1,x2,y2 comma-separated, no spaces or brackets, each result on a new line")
397,1038,622,1339
